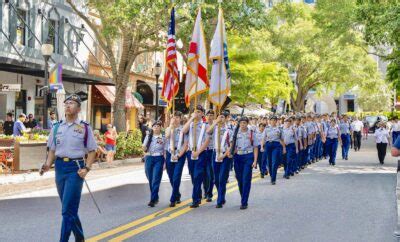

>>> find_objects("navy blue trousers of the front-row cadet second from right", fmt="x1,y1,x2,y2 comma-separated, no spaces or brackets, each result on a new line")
213,155,232,205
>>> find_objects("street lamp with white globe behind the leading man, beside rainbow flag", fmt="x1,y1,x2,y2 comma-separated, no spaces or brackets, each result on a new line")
40,39,54,129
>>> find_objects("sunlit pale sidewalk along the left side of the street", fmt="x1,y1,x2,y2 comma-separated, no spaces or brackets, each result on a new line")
0,158,143,199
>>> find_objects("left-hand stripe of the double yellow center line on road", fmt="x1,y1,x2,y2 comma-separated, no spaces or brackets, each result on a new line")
86,173,259,242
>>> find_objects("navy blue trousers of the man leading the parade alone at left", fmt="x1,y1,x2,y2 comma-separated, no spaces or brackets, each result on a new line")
55,158,84,242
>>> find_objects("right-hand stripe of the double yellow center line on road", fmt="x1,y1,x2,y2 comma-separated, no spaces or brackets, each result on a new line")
109,176,261,242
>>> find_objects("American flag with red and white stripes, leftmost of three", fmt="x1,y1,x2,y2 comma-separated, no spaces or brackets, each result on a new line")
161,8,179,109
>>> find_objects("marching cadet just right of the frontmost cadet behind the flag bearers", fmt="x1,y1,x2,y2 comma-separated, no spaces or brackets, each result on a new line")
282,118,299,179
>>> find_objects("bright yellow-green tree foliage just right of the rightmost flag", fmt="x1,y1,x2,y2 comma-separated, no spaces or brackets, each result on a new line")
229,30,293,106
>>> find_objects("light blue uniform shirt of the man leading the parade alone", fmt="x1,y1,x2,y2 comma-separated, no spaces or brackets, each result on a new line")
47,119,97,159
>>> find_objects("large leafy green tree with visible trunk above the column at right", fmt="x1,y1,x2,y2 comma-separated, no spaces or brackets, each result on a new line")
267,3,376,111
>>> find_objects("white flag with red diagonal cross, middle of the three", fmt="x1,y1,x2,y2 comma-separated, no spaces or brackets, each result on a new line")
185,9,209,106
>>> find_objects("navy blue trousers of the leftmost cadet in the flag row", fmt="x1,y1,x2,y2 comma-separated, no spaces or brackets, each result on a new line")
144,155,164,202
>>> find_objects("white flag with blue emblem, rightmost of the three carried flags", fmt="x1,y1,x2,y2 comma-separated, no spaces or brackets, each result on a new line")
208,8,231,107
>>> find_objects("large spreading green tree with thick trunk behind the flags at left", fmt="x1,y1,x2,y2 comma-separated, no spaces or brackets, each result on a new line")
66,0,265,131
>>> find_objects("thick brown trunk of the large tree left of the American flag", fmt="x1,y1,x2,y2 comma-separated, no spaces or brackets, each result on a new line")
113,76,127,132
